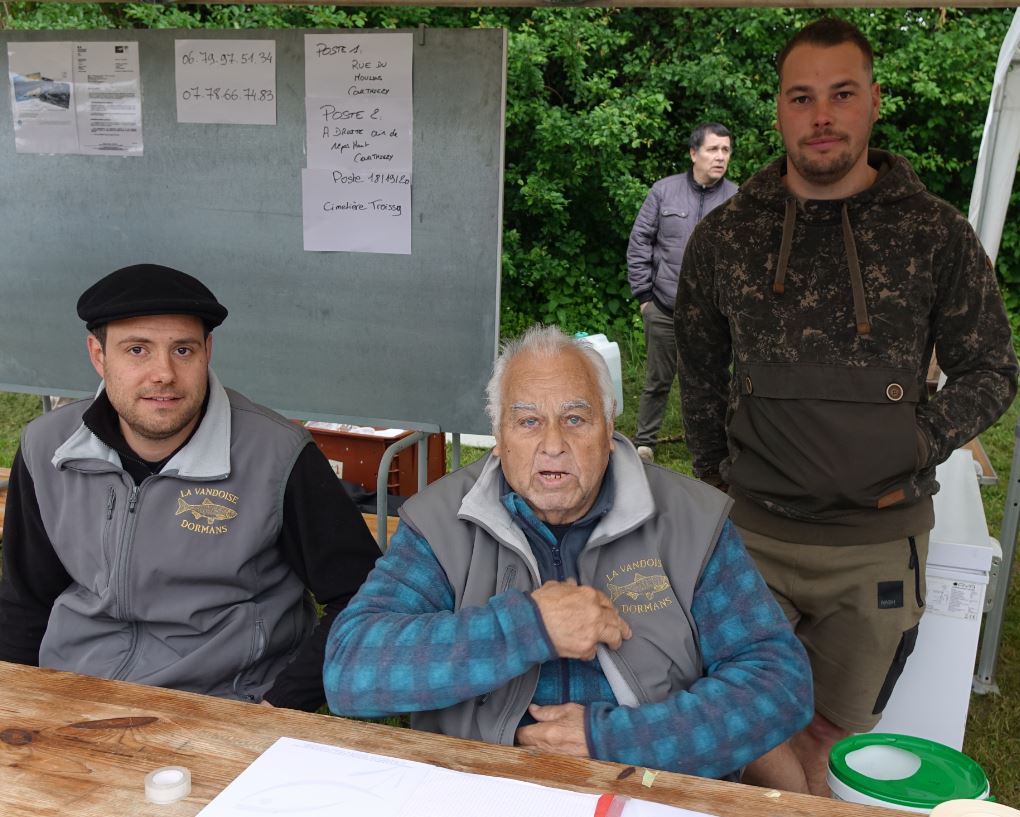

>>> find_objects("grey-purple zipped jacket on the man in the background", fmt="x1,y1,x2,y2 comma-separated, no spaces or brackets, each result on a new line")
627,170,736,315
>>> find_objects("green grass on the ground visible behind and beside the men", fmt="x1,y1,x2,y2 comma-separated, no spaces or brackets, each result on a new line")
0,352,1020,807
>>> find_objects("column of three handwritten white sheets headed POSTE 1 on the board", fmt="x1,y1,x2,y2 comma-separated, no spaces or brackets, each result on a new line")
302,34,413,254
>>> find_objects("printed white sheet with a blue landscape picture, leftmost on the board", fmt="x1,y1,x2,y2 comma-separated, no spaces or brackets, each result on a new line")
7,43,78,153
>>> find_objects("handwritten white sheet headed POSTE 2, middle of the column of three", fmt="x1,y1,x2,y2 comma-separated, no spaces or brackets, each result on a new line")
305,97,411,170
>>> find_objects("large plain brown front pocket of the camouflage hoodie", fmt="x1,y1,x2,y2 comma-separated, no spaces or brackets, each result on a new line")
723,364,919,519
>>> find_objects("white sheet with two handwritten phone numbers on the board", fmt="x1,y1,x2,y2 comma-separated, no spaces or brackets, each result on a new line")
173,40,276,124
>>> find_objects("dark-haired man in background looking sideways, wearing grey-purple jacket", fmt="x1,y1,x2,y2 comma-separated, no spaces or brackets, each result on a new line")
627,122,736,462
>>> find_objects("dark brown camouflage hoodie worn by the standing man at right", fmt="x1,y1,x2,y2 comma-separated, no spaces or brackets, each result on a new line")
674,150,1017,545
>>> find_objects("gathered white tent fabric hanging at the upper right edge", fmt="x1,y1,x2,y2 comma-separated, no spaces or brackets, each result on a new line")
970,9,1020,261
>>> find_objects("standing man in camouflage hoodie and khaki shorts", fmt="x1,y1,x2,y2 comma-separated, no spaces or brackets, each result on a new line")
674,19,1017,795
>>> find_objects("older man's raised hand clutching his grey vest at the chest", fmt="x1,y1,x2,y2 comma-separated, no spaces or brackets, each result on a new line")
531,578,631,661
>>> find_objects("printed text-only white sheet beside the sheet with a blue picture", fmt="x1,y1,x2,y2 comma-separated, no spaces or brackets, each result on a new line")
73,42,142,156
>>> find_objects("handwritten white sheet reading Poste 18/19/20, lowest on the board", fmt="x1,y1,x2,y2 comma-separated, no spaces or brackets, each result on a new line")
301,167,411,255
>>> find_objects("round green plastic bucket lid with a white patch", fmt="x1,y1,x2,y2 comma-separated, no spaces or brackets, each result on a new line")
829,732,988,809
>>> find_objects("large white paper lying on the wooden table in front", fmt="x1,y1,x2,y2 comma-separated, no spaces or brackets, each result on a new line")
199,737,722,817
